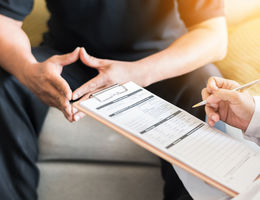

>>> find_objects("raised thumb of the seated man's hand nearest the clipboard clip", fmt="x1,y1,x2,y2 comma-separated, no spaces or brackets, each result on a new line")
79,48,111,68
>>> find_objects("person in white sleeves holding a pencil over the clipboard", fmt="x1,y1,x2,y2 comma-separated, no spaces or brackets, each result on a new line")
202,77,260,200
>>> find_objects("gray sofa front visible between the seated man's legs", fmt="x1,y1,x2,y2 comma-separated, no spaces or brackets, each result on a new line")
38,108,163,200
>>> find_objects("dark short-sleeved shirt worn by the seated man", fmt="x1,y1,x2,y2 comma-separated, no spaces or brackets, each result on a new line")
0,0,224,60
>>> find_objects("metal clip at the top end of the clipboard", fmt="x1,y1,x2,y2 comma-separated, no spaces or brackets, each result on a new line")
90,84,128,102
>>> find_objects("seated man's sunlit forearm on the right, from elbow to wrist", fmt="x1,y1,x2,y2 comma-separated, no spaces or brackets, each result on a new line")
140,17,227,84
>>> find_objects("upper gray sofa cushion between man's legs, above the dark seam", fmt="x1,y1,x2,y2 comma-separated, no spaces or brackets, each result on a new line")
39,108,159,165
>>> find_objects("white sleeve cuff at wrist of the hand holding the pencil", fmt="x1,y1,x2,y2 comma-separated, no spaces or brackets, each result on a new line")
244,96,260,146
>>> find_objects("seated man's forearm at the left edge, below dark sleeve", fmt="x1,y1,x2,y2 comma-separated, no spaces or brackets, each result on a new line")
0,15,36,81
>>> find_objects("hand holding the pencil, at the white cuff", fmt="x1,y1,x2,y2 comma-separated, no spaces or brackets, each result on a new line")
202,77,255,131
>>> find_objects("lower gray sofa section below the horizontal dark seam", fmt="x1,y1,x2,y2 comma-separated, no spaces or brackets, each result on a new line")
38,162,163,200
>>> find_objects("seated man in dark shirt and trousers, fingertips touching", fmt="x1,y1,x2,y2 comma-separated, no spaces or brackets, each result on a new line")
0,0,227,200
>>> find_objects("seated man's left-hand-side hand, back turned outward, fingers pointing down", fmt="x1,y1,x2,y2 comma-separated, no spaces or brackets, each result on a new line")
18,48,80,122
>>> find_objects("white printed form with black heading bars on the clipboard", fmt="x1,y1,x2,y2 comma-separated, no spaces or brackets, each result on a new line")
80,82,260,193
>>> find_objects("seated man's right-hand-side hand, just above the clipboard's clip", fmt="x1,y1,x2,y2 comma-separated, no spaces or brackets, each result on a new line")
72,48,150,121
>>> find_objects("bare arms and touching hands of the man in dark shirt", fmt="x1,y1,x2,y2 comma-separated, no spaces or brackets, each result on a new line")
0,15,227,122
